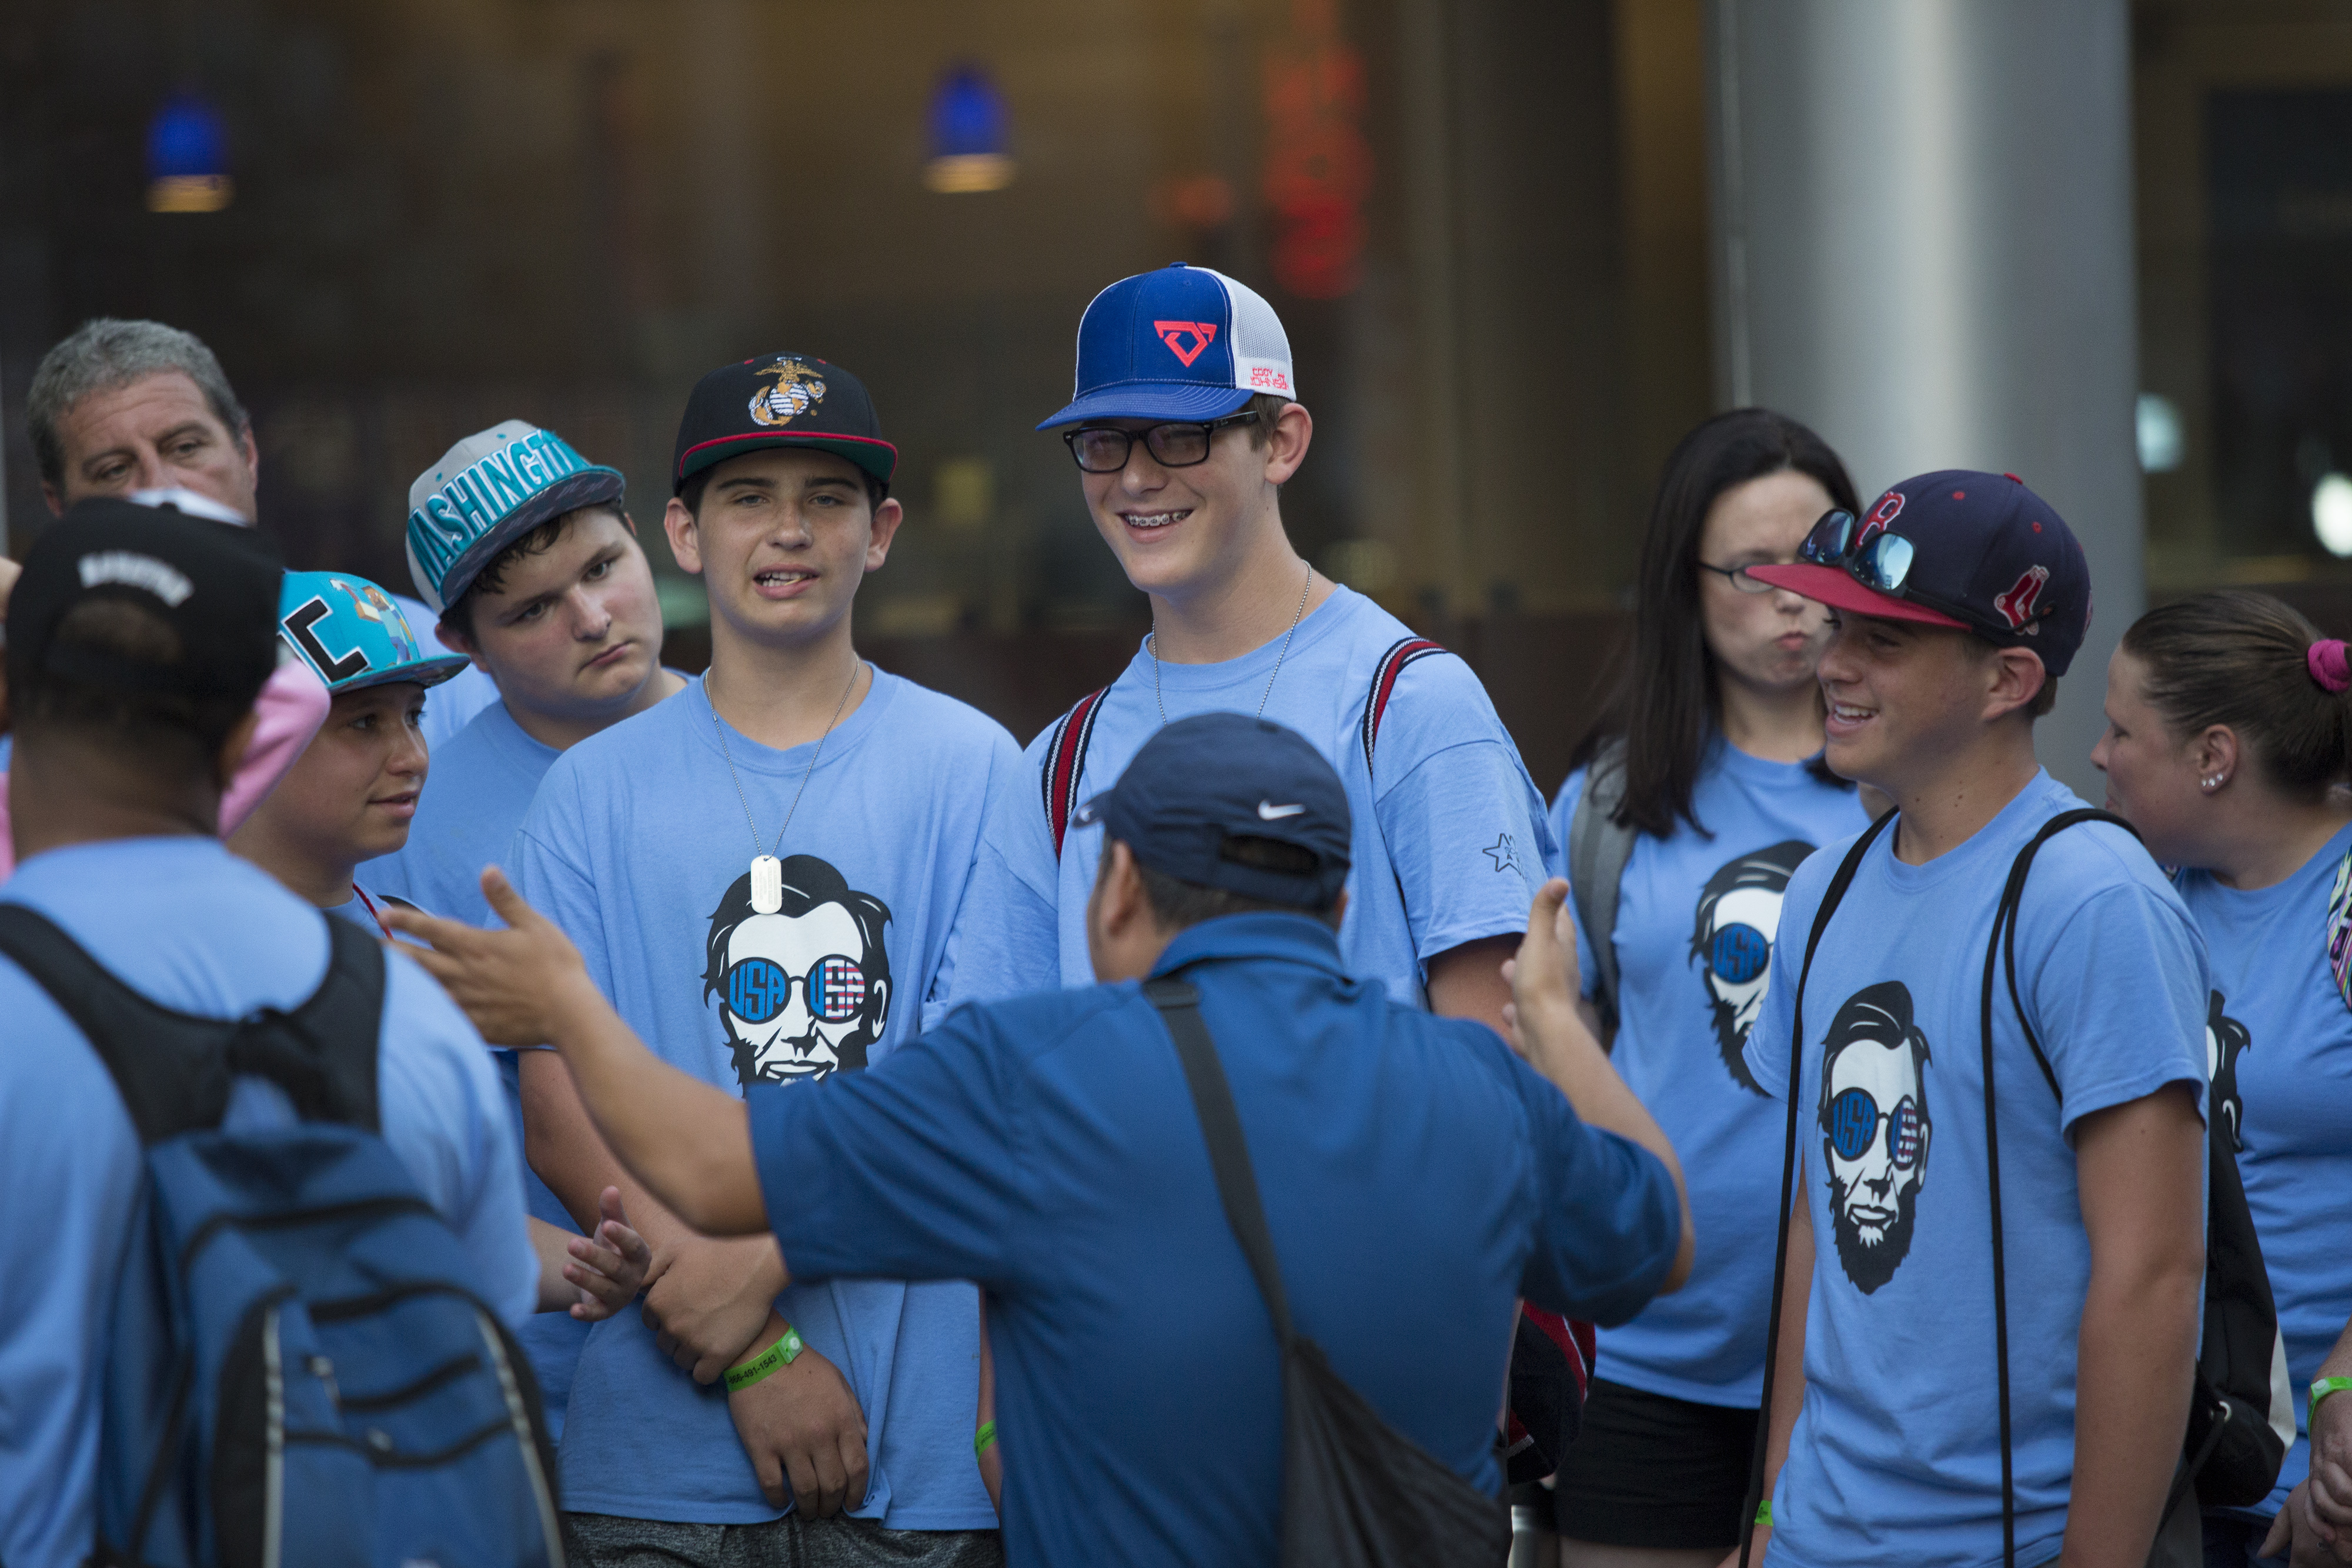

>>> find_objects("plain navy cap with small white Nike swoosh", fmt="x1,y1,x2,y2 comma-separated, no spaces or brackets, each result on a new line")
1070,713,1352,910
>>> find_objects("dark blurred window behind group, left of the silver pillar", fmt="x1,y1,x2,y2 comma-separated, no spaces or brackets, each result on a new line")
0,0,1693,790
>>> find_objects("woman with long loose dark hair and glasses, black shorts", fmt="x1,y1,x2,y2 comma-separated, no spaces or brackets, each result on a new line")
1552,409,1867,1568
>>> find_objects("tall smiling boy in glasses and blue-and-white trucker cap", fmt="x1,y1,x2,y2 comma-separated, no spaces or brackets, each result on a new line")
964,266,1552,1044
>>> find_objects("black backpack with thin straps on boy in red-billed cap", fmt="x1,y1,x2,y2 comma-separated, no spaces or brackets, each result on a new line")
1740,806,2296,1568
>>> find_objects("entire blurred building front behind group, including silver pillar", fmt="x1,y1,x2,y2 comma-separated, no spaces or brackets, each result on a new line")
0,0,2352,790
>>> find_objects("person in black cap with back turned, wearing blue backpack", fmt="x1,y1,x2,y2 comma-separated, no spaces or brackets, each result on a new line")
0,501,543,1568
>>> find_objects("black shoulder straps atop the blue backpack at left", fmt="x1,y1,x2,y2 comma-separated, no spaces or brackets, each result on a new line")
0,902,383,1142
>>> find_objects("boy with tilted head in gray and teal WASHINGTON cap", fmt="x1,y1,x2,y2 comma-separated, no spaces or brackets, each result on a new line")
360,419,687,1436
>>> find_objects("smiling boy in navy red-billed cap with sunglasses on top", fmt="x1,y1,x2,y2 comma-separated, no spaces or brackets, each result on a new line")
1748,470,2209,1568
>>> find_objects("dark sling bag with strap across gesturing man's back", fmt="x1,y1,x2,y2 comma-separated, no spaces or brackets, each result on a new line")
1143,978,1510,1568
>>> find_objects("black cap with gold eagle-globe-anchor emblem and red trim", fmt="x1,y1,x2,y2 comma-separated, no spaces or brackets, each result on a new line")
670,355,898,496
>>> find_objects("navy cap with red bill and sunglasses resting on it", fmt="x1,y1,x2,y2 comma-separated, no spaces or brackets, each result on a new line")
1748,468,2091,680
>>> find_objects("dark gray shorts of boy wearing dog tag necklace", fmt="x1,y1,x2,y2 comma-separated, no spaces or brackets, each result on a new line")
564,1514,1004,1568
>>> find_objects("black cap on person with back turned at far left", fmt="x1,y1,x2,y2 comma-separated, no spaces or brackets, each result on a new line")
7,496,285,708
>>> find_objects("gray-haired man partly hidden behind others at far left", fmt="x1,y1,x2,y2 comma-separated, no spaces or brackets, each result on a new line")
26,315,499,748
